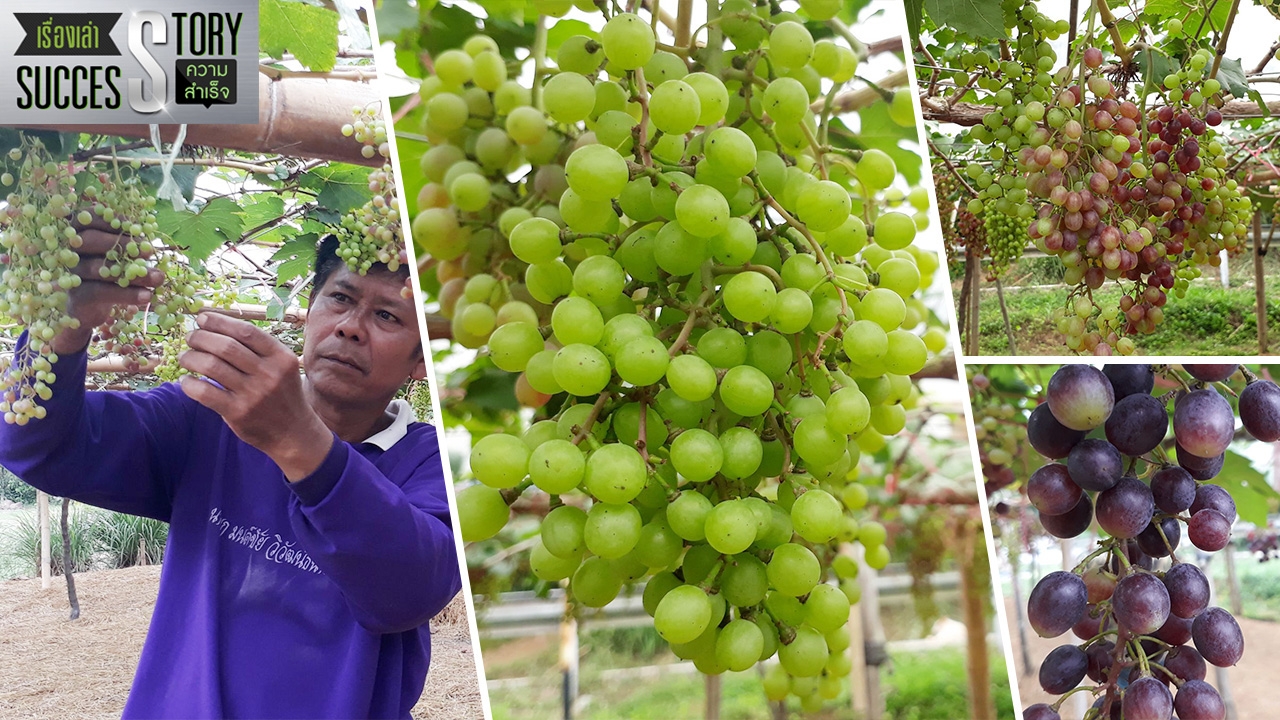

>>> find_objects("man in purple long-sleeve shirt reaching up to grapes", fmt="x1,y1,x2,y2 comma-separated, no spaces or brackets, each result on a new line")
0,220,461,717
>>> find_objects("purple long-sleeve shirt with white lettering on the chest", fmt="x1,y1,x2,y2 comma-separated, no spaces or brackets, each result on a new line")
0,338,461,719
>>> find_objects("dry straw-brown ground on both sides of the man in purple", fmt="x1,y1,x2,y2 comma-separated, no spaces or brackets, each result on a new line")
0,566,483,720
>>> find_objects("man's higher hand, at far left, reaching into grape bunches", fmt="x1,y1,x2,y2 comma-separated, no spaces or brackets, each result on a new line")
52,218,164,355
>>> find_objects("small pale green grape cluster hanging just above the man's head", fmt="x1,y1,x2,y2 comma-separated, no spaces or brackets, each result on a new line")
338,105,404,274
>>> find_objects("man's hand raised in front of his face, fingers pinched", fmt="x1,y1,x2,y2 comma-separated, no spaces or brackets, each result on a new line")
178,313,333,482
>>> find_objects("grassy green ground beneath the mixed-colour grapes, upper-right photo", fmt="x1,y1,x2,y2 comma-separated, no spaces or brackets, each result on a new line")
952,245,1280,356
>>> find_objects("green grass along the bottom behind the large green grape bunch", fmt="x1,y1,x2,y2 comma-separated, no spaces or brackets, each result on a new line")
489,643,1014,720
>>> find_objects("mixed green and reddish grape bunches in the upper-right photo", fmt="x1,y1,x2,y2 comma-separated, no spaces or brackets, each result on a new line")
936,1,1251,355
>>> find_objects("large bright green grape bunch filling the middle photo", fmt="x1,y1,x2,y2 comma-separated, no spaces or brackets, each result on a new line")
412,0,946,707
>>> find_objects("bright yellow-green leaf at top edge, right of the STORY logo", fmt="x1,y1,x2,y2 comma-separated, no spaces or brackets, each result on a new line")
257,0,338,73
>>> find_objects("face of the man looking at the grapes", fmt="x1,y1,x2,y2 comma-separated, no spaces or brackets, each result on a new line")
302,264,426,405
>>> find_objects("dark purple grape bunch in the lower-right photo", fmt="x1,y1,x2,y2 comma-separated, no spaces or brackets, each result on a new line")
1024,365,1280,720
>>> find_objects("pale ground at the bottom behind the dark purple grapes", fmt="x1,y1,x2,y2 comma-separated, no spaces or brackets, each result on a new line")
1005,601,1280,720
